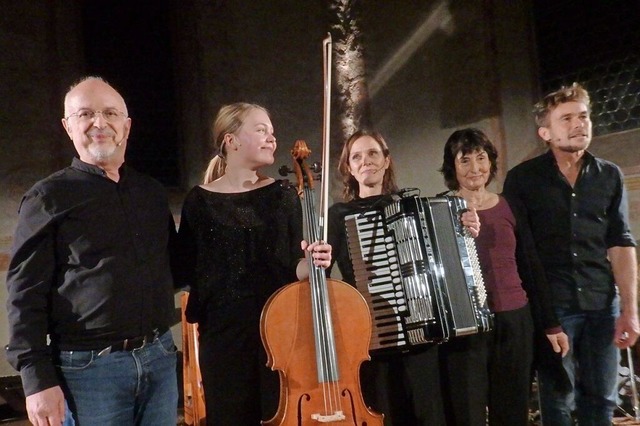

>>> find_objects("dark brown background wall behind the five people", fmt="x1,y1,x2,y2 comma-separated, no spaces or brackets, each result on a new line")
0,0,640,374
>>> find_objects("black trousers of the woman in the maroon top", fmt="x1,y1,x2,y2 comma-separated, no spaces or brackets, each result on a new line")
440,305,533,426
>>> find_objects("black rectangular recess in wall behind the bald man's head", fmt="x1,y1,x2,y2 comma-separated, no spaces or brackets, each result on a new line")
80,0,179,186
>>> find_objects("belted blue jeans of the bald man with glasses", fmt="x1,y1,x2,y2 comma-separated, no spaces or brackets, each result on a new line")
59,331,178,426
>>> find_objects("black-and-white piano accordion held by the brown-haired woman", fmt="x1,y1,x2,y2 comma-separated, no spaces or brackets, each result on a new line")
345,195,493,352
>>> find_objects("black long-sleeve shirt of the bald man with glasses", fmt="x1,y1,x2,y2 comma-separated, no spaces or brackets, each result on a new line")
7,158,175,395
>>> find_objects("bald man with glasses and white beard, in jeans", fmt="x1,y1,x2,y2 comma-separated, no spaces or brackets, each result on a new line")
7,77,178,426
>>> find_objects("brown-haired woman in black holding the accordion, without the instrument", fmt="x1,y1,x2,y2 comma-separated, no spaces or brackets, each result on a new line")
328,130,479,426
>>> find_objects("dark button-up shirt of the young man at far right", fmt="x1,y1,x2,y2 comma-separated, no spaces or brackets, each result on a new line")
504,151,636,310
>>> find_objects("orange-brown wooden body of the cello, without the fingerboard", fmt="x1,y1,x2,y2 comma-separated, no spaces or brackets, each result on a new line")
260,279,383,426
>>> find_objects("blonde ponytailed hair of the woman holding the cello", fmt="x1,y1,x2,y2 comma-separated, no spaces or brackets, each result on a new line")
202,102,269,185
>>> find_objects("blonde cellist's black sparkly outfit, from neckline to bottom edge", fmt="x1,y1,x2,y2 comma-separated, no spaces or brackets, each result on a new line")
177,181,303,425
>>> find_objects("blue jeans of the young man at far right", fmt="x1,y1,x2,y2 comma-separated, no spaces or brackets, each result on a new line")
538,297,620,426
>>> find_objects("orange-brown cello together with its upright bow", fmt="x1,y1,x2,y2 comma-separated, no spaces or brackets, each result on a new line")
260,37,383,426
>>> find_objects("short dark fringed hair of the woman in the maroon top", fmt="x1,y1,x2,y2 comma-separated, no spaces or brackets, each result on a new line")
440,128,498,191
